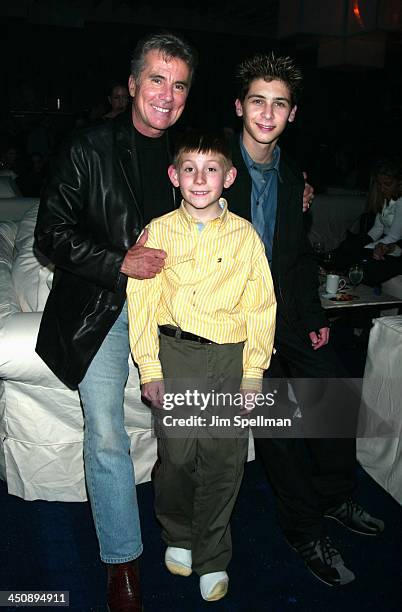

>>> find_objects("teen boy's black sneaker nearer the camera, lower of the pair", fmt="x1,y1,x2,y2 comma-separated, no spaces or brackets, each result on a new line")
289,536,355,586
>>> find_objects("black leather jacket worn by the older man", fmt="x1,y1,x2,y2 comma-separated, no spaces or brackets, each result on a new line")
35,114,174,388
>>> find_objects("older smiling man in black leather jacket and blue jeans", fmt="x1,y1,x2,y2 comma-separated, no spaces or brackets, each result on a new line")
35,34,195,612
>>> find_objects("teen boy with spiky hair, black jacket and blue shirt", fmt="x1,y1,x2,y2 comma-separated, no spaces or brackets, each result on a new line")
228,54,384,586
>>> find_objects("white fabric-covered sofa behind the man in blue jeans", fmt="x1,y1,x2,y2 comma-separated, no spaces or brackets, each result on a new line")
0,200,156,501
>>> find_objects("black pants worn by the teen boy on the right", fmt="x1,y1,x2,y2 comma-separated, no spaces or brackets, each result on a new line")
255,315,357,542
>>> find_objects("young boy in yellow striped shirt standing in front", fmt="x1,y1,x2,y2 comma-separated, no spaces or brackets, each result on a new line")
127,132,276,601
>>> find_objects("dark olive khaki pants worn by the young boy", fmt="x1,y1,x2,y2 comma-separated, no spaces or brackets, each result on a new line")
154,336,248,575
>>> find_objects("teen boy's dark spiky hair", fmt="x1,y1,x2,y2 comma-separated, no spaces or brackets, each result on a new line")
236,53,303,106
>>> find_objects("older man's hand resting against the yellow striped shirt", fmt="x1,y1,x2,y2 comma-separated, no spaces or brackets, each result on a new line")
120,229,166,280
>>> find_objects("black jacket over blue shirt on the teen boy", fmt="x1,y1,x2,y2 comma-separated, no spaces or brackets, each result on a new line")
224,136,328,336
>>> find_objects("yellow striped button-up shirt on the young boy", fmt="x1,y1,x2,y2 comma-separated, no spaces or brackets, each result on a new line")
127,198,276,388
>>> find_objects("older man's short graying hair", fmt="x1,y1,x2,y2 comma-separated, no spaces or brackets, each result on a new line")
131,32,197,83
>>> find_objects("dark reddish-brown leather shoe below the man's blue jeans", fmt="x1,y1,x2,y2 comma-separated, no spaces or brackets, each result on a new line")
106,560,143,612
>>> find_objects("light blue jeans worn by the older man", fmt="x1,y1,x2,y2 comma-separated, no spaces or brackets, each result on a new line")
79,304,142,563
